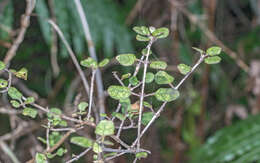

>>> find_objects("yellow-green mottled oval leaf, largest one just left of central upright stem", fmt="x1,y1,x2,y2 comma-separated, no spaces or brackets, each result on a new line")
107,85,131,100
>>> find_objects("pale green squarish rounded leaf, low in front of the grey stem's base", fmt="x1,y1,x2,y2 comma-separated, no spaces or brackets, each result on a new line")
95,120,115,136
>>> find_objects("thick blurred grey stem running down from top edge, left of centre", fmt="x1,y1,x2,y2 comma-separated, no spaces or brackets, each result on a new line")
74,0,105,113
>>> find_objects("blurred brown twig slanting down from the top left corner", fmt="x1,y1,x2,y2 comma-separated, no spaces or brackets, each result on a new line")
4,0,36,64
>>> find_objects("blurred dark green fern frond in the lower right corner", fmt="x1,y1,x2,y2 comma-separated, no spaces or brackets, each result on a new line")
191,115,260,163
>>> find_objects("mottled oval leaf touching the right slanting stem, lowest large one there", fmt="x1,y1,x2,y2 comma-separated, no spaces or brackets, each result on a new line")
155,88,180,102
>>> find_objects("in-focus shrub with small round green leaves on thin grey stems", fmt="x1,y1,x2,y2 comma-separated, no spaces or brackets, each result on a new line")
0,22,221,163
